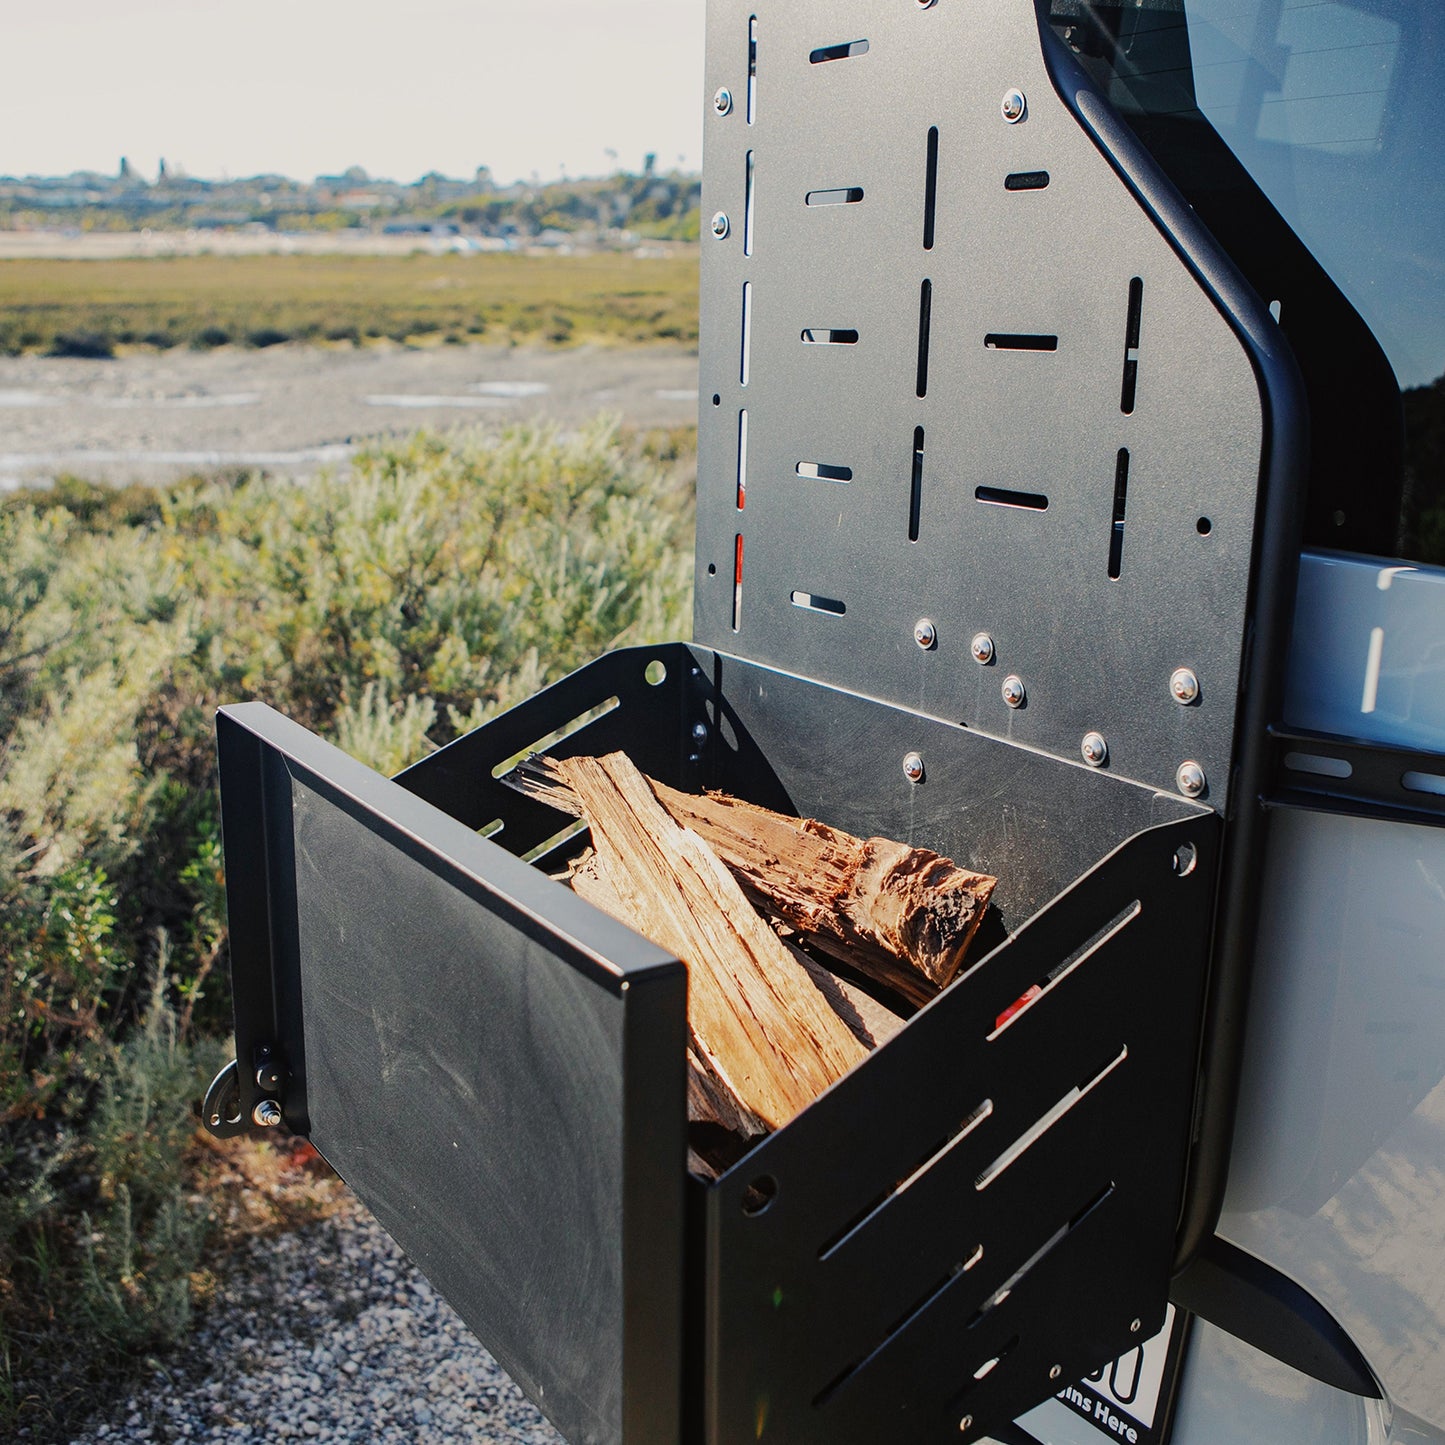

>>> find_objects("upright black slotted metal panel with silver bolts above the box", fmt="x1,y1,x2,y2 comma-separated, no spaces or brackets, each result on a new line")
695,0,1266,806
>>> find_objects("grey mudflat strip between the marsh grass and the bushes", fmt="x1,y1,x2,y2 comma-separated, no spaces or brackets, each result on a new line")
0,344,698,490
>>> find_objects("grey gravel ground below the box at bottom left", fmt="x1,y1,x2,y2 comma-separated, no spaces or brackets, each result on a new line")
74,1201,562,1445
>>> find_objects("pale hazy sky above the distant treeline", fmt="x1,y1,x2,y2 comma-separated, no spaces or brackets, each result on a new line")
0,0,704,181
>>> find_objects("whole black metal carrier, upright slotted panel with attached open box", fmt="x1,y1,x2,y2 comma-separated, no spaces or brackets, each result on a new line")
208,0,1301,1445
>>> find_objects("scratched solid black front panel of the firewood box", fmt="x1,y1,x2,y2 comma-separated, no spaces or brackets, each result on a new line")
212,704,686,1445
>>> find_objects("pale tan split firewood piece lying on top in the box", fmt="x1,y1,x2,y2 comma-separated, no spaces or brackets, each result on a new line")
559,753,868,1129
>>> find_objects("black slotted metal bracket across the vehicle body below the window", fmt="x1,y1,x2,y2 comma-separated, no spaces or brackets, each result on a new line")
1266,727,1445,828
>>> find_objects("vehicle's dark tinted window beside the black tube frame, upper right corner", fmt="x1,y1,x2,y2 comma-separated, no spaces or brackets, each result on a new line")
1052,0,1445,564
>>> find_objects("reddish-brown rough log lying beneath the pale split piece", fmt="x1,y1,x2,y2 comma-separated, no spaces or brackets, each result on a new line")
507,756,997,1004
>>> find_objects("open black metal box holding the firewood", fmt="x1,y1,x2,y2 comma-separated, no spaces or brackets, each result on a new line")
206,644,1220,1445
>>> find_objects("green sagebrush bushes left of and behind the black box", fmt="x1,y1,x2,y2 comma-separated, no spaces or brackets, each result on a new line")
0,420,692,1425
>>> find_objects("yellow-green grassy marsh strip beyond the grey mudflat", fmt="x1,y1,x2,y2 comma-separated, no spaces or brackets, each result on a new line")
0,251,698,355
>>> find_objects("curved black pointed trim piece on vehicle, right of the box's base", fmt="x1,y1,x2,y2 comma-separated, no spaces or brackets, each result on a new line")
1169,1235,1384,1400
